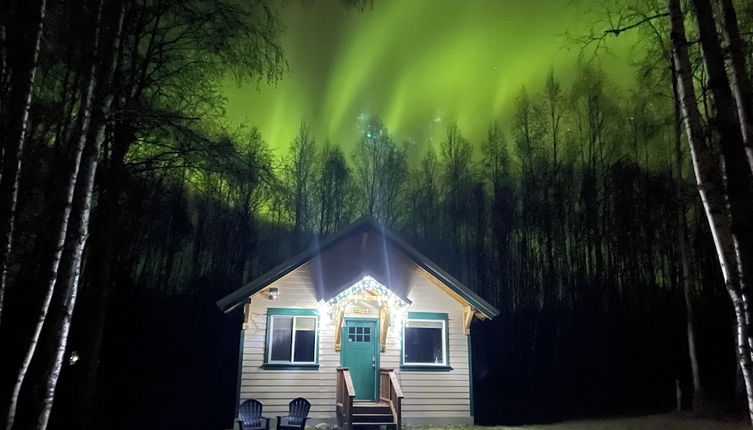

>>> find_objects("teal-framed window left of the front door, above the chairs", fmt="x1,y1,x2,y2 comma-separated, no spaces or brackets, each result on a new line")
264,308,319,367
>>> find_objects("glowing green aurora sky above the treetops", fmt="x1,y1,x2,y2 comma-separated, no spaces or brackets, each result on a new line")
220,0,632,158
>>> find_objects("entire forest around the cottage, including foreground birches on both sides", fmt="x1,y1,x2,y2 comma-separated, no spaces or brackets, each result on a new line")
0,0,753,430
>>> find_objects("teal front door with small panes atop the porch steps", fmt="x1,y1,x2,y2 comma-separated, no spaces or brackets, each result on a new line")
340,318,379,400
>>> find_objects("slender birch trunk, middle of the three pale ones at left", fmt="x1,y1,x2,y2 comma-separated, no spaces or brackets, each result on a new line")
4,2,101,430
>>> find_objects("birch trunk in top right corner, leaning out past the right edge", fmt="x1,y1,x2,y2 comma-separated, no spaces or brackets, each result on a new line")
717,0,753,169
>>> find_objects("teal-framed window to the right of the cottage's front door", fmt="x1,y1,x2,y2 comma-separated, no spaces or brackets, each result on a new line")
402,312,450,370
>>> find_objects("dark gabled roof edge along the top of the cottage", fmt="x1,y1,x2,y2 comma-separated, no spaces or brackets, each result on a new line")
217,218,499,318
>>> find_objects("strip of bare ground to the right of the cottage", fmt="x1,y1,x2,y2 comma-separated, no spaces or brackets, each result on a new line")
413,414,750,430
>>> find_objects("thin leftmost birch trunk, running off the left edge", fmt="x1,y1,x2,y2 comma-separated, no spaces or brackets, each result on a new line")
0,0,47,323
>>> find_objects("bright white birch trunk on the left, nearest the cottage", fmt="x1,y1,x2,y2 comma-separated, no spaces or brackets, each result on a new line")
28,0,125,430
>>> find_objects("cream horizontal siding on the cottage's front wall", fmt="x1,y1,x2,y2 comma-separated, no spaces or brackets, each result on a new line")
240,265,472,424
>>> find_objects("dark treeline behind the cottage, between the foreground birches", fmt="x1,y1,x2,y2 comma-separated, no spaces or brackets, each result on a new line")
30,68,736,427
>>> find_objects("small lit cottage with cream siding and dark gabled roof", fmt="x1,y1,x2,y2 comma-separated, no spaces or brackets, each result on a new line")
217,219,498,430
